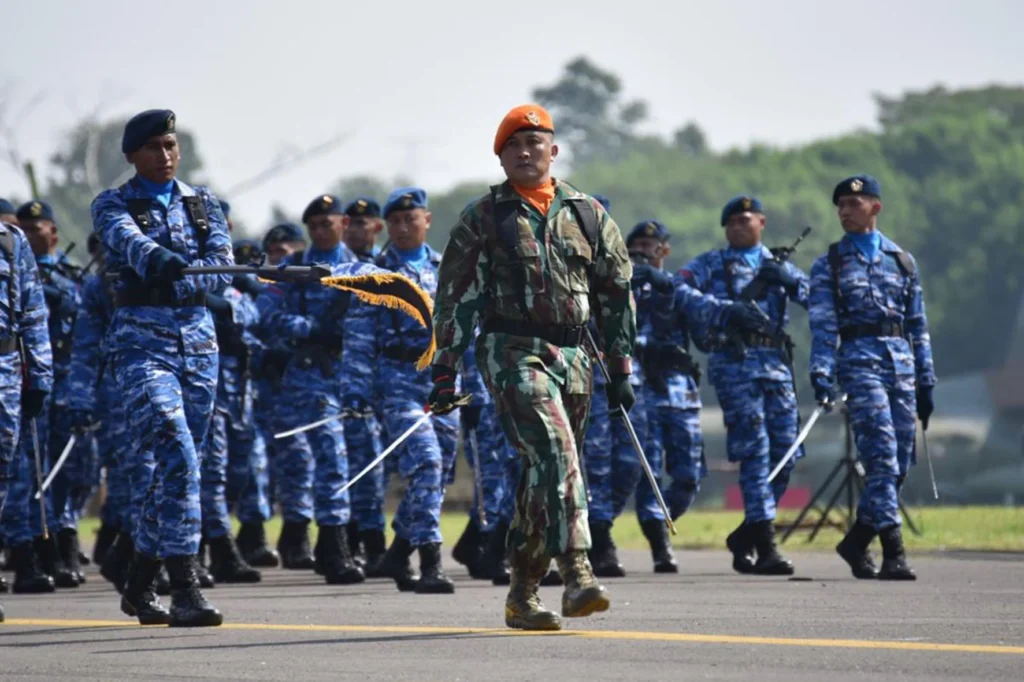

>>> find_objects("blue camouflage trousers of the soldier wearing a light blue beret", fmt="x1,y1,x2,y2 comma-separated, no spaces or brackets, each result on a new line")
381,372,459,547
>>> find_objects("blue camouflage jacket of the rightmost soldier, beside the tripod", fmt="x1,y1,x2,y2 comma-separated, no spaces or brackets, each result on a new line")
810,235,935,386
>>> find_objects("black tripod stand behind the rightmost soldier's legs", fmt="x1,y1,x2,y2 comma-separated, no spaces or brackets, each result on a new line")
779,402,921,543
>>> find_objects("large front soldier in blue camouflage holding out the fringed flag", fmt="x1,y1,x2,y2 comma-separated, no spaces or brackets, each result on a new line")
92,110,234,627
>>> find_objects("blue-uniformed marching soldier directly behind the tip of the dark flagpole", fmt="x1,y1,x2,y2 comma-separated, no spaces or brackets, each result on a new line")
257,195,365,585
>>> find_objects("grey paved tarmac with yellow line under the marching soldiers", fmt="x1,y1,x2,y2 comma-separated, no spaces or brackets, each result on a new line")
0,549,1024,682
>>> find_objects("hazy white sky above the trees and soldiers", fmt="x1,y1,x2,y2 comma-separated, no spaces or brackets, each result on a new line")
0,0,1024,229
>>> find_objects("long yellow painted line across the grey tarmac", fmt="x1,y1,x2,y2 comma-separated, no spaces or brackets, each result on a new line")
0,619,1024,655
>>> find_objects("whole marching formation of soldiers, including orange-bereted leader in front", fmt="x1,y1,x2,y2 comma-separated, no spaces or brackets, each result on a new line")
0,104,935,630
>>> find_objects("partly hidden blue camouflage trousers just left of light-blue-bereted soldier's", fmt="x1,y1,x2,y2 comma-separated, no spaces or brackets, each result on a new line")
345,409,387,530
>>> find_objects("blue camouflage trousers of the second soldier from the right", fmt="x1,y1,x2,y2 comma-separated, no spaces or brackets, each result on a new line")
715,379,803,523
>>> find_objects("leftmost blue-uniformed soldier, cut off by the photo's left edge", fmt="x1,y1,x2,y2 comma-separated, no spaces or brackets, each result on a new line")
0,218,53,606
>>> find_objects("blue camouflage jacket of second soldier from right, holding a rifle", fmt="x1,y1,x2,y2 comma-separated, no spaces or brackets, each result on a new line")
680,246,809,384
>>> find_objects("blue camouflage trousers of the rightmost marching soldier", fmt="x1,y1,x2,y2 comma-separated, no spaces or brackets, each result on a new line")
839,367,918,530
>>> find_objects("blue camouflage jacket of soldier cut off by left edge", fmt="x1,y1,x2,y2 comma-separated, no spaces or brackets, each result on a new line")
0,222,53,392
